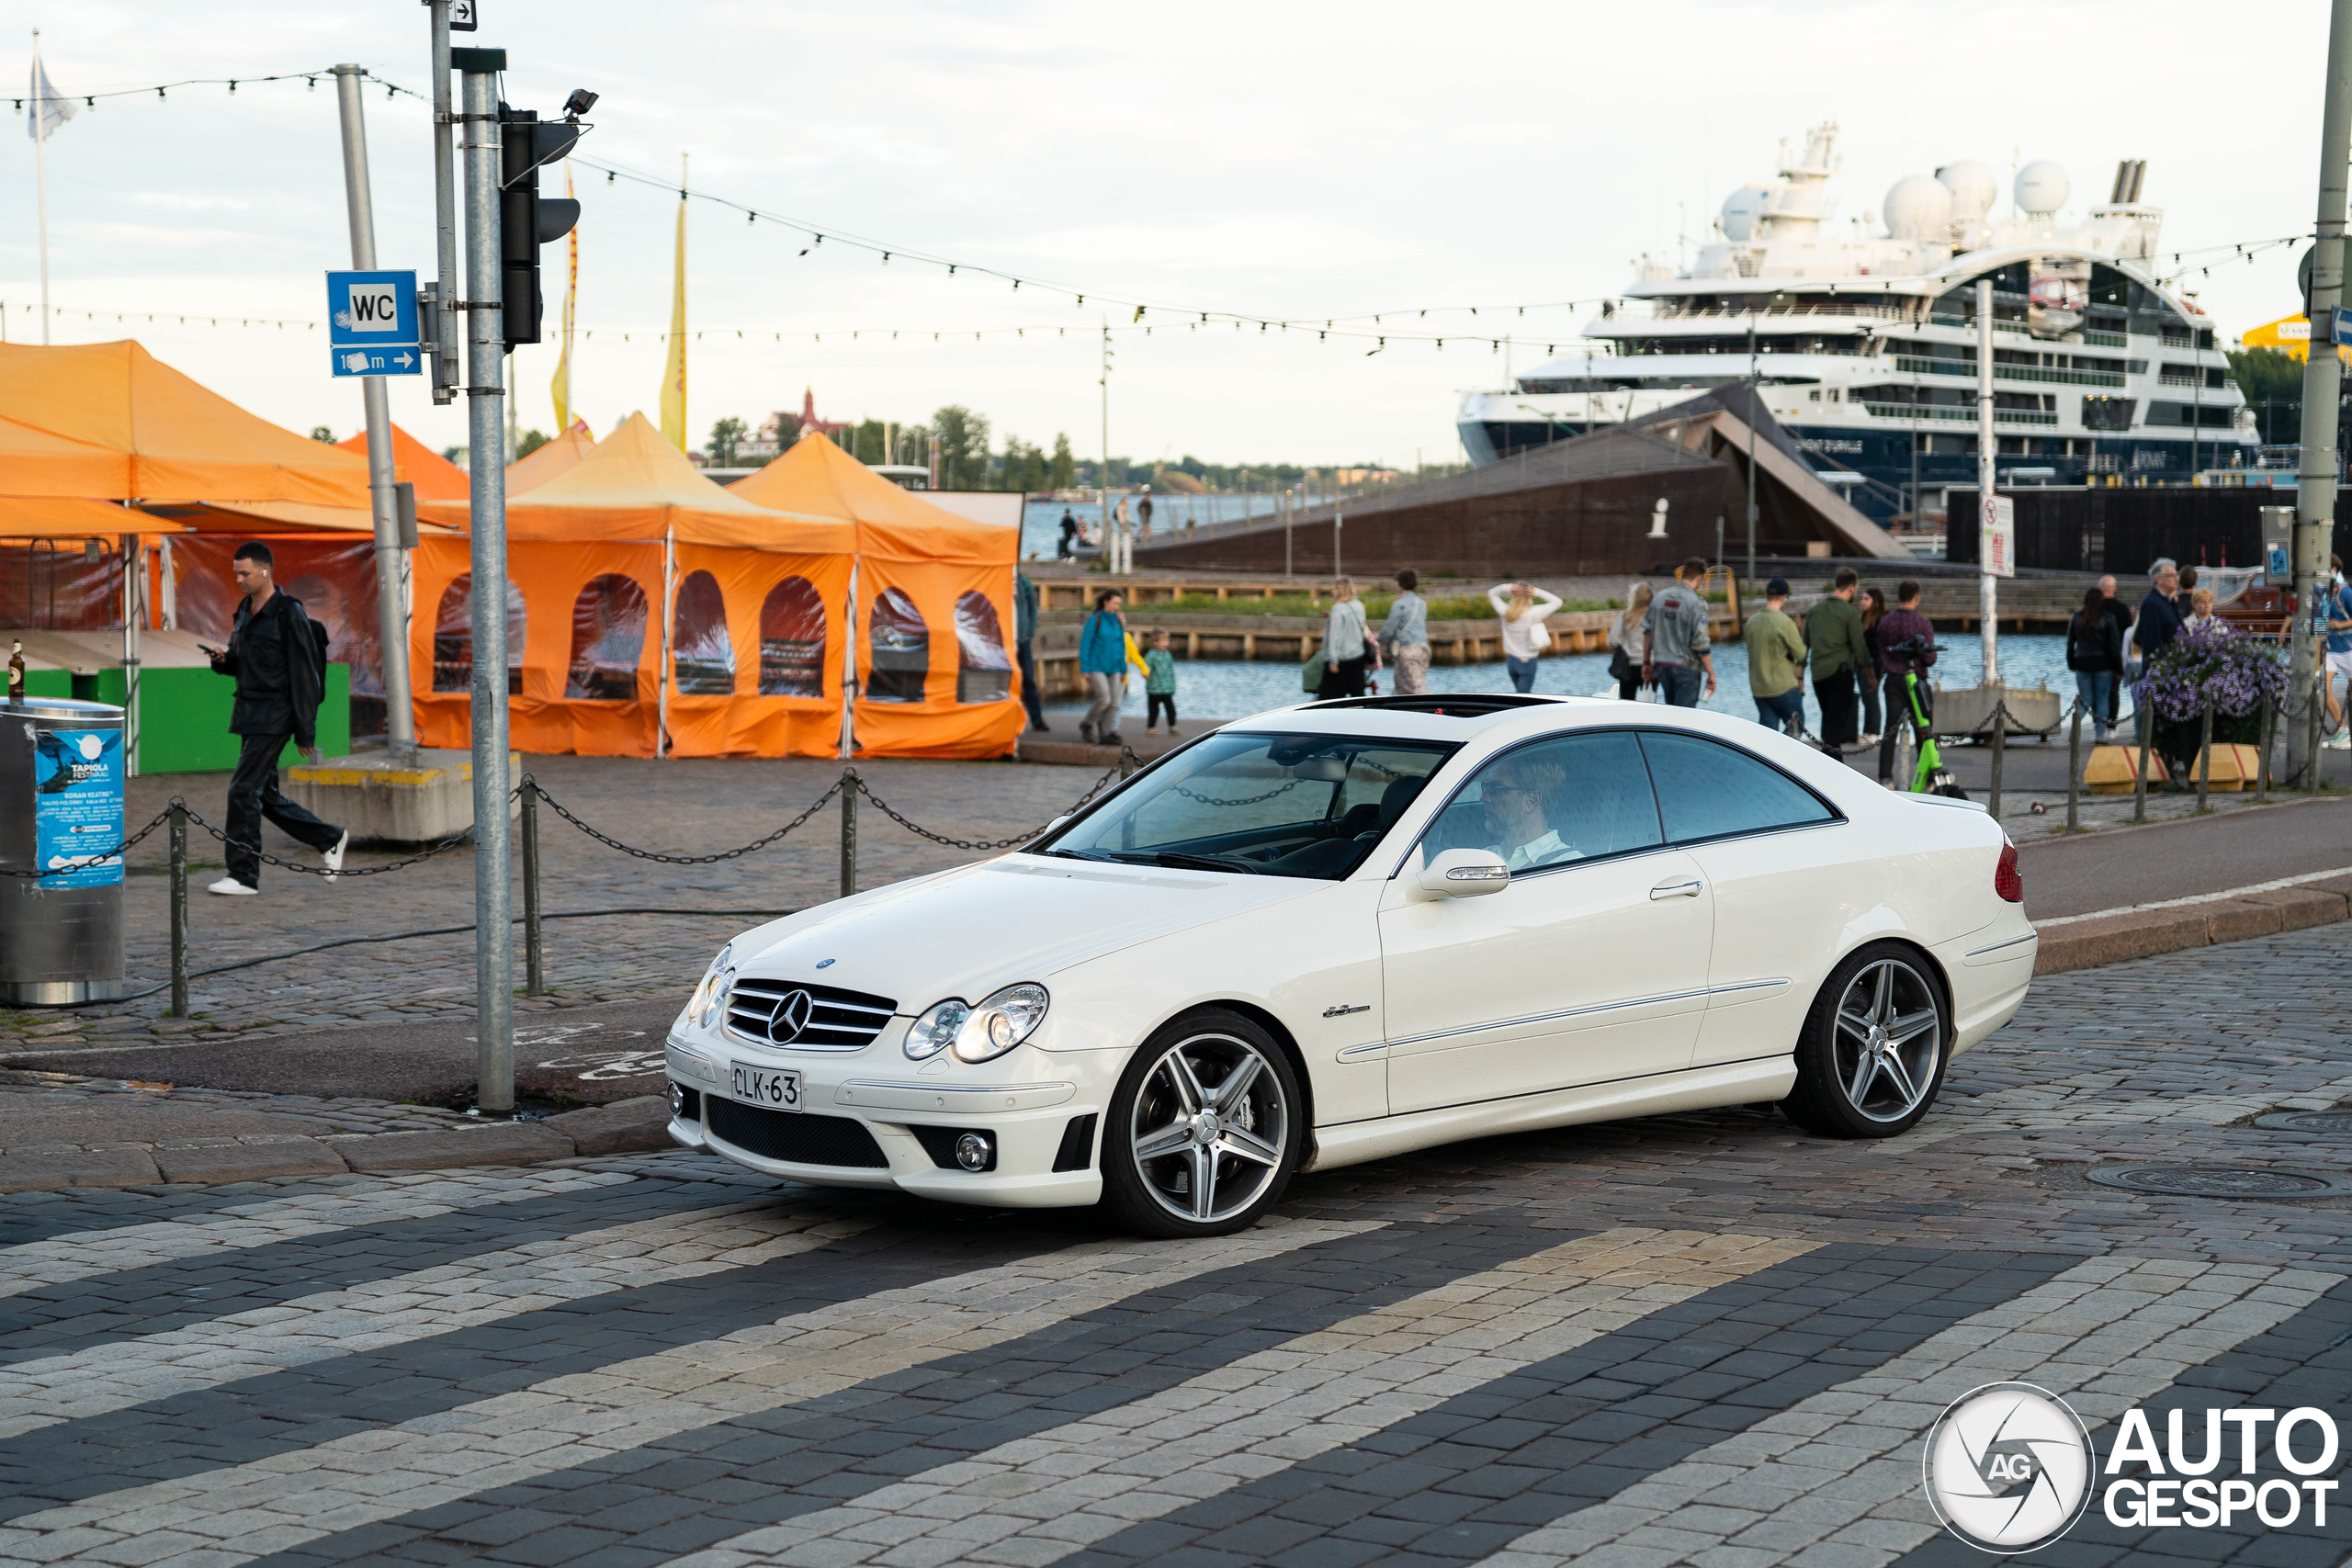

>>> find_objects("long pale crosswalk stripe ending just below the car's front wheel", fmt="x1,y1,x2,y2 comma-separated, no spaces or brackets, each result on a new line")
0,1220,1383,1568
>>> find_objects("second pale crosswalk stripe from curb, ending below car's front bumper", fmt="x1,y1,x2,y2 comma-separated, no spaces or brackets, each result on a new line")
0,1201,873,1438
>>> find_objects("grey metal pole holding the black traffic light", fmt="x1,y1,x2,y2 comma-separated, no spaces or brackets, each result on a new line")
460,61,513,1117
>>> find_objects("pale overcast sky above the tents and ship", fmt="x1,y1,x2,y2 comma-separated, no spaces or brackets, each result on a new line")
0,0,2326,463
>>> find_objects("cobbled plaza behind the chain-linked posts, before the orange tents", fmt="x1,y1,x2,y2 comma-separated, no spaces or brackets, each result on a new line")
0,757,1119,1048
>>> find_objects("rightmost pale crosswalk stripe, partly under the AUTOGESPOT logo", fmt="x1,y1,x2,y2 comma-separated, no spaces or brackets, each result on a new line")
1479,1258,2343,1568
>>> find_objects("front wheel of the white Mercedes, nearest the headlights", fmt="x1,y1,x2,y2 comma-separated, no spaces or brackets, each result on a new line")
1103,1009,1306,1239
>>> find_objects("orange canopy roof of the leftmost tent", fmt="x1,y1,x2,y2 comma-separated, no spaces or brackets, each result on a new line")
0,341,367,513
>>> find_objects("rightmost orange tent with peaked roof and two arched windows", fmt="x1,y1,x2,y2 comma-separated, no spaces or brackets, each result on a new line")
727,433,1023,757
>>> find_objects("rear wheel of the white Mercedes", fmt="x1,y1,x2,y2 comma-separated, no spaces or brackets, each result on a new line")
1781,942,1952,1138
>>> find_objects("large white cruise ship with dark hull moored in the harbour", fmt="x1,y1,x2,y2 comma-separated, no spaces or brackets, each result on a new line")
1461,125,2258,526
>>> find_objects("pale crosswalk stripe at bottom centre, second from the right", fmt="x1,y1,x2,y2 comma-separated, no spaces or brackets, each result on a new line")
673,1229,1818,1568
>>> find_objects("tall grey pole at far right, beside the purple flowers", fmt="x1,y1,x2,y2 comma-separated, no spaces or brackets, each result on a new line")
2286,0,2352,787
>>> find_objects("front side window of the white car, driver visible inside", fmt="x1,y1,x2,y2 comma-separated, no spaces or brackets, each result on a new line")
1423,731,1663,872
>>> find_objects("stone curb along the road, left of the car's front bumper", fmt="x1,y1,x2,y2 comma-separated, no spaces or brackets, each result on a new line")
0,1096,675,1192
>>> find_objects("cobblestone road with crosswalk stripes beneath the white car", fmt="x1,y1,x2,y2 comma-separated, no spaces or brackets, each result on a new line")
0,926,2352,1568
